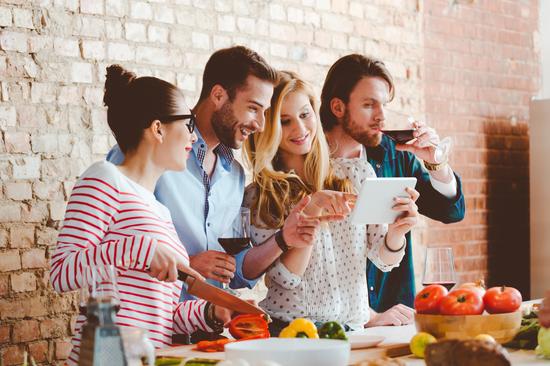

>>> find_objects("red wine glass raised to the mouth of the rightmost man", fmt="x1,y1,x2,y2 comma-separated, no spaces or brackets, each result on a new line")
382,110,452,163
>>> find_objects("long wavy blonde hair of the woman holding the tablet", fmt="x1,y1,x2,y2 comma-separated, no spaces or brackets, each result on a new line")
243,71,352,228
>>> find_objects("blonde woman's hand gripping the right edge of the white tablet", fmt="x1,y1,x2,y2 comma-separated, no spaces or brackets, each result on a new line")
386,187,420,249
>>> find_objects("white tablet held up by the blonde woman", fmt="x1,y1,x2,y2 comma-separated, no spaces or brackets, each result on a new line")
351,177,416,224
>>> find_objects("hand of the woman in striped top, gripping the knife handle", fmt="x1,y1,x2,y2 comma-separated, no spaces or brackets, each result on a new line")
149,243,204,282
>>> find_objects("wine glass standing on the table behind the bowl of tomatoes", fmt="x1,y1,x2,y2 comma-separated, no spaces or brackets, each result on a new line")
422,247,457,291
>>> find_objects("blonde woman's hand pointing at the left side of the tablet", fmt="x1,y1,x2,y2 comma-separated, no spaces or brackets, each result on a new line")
304,190,357,216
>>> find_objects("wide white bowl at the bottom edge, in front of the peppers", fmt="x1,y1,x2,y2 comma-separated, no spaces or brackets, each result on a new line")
225,338,350,366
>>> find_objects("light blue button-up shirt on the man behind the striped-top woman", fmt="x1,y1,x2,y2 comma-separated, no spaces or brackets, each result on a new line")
107,129,258,298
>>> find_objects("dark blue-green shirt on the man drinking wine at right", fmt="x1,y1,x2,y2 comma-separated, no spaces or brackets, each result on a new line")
366,135,466,312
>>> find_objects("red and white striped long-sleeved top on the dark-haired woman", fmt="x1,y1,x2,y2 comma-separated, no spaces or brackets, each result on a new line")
50,162,212,364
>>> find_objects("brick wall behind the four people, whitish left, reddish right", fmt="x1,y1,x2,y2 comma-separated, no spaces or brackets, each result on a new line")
0,0,538,365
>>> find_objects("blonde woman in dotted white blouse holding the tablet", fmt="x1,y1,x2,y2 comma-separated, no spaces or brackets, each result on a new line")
244,72,418,335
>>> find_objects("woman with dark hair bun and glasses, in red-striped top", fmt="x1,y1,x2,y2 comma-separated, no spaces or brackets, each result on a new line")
50,65,231,364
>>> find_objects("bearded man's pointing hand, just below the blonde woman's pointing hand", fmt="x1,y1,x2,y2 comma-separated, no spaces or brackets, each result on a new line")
281,196,344,248
